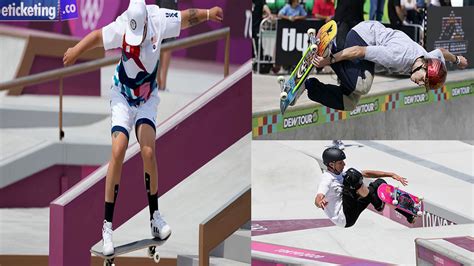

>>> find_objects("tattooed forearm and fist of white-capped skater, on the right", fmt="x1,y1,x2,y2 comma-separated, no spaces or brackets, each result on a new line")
181,6,224,29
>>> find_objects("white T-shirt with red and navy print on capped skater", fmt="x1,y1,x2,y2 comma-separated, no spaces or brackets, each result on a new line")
102,5,181,105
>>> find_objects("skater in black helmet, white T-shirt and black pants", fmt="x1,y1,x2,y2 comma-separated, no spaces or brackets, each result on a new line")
314,147,415,227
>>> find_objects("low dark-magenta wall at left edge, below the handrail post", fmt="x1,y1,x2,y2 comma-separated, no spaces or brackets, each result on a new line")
0,165,98,208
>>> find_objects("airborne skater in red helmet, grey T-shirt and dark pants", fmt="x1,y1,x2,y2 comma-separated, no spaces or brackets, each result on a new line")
303,21,468,111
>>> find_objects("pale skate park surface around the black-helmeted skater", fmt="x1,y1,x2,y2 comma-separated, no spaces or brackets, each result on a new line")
252,141,474,265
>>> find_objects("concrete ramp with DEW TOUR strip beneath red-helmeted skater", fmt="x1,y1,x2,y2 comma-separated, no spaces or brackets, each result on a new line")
252,70,474,140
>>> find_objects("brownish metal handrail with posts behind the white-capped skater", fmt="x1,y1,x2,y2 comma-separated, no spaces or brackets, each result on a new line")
0,27,230,140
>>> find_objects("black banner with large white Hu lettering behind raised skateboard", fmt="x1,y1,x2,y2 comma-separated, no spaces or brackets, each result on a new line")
275,19,324,66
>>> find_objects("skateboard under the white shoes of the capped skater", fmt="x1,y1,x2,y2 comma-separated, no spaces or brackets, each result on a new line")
91,238,166,266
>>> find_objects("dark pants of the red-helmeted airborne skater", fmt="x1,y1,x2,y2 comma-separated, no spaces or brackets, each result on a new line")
305,29,375,110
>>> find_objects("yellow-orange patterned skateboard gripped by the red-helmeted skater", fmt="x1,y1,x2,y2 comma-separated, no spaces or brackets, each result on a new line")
277,20,337,114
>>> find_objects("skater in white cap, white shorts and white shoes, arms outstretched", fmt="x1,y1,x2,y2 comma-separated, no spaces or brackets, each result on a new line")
63,0,223,255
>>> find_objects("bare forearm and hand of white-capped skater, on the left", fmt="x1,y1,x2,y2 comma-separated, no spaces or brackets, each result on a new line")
63,29,103,66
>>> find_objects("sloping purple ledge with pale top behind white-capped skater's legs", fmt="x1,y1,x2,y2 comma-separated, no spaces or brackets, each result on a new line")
49,62,251,265
